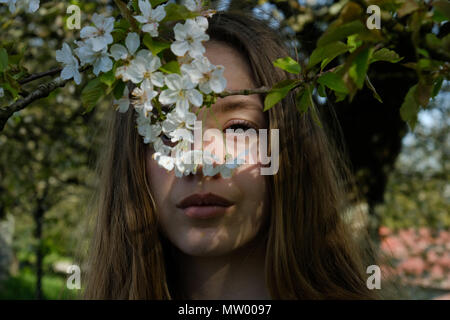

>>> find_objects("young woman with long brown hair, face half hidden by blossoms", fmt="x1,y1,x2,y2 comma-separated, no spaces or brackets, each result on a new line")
85,13,377,299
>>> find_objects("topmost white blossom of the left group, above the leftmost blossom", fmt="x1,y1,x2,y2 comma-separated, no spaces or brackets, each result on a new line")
80,13,114,51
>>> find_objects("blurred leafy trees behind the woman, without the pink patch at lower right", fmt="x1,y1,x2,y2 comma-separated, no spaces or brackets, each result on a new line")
0,0,450,299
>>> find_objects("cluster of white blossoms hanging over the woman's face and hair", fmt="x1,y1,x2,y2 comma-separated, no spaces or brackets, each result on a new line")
54,0,237,177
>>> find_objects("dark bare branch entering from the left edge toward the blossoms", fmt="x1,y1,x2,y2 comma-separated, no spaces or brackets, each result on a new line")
0,66,91,131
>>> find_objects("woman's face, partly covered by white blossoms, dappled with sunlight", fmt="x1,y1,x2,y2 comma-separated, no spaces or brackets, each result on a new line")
146,41,268,256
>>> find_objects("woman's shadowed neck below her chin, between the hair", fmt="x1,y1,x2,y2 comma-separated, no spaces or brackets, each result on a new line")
177,232,270,300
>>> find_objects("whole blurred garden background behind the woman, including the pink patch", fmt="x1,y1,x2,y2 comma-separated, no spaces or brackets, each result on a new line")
0,0,450,299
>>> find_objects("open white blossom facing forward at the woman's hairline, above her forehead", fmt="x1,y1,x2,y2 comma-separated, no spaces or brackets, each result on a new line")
170,18,209,58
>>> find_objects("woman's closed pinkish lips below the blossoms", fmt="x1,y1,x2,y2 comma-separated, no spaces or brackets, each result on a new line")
177,193,233,219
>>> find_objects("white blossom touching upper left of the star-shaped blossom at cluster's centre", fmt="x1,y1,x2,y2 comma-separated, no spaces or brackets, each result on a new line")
122,50,164,87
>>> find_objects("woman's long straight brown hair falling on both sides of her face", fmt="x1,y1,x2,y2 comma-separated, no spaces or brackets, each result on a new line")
85,13,376,299
